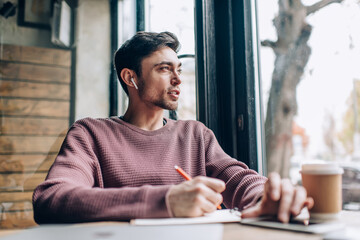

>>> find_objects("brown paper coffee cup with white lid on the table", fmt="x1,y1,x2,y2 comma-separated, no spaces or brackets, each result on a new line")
300,163,344,220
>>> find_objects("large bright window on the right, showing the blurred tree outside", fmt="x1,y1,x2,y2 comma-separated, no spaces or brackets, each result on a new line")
258,0,360,208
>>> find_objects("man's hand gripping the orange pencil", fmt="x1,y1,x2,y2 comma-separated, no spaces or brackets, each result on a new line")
166,176,225,217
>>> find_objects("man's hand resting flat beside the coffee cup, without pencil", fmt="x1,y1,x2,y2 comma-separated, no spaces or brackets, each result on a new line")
241,173,314,223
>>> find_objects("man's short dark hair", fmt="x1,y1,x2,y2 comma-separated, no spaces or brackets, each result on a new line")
114,32,180,94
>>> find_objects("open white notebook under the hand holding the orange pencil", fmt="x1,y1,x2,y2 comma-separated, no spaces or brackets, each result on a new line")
130,209,241,225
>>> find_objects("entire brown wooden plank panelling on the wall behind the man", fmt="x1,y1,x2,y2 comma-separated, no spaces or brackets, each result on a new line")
0,45,71,229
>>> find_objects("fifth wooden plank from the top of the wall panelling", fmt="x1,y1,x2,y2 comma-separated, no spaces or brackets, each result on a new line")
0,117,69,136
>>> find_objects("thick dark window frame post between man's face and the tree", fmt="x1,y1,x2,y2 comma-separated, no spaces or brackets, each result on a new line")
195,0,265,172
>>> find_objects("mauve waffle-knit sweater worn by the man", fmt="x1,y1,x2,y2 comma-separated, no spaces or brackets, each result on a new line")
33,117,266,224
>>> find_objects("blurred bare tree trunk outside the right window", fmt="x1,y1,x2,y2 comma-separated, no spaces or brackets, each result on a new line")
261,0,343,177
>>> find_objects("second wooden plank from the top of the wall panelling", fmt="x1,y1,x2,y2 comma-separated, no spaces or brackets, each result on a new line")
0,62,70,83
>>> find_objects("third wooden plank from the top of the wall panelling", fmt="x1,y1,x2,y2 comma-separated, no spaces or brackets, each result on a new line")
0,80,70,100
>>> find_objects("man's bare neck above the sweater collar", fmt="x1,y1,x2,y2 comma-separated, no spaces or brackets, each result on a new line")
123,107,164,131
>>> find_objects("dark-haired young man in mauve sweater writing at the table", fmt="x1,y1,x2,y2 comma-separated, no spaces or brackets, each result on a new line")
33,32,312,223
